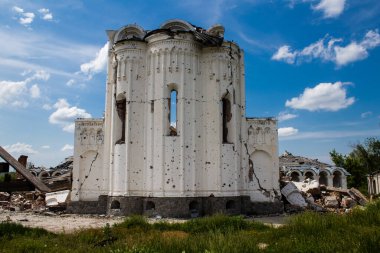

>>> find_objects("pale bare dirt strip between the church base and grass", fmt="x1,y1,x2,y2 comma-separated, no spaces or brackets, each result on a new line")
0,210,287,233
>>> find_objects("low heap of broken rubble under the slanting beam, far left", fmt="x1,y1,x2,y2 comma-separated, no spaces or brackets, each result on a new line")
0,191,46,211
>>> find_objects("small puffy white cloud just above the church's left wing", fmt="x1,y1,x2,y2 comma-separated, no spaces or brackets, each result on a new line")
49,98,91,133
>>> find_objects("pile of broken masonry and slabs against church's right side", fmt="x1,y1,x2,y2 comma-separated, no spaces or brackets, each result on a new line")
281,179,368,213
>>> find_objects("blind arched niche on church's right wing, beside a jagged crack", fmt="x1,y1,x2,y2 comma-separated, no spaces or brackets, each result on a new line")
251,150,278,189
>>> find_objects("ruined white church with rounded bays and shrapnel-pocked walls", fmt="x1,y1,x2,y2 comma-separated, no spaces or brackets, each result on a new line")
69,20,282,217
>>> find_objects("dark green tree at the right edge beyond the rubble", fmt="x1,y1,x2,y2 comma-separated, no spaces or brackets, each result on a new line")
330,138,380,193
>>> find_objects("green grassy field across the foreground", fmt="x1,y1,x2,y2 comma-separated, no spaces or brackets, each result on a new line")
0,201,380,253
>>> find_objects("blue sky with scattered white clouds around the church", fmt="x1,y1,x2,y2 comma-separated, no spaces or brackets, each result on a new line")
0,0,380,166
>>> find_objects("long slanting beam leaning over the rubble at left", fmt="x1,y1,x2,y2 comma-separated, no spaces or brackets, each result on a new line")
0,146,51,192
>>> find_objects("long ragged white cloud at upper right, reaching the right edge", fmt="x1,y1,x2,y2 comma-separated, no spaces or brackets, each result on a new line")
272,30,380,67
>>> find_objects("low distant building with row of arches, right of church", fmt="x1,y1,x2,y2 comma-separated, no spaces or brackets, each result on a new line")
279,151,350,189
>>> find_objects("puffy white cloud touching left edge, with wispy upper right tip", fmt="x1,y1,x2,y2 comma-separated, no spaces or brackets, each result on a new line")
0,71,50,107
